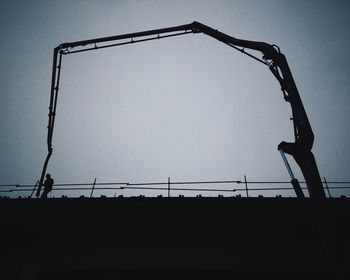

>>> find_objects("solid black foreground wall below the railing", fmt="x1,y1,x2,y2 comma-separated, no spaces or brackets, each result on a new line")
0,198,350,279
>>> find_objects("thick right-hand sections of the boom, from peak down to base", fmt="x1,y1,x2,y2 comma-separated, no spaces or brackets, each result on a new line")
193,22,325,198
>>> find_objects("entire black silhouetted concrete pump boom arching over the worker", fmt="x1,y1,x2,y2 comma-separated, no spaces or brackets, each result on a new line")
36,21,325,198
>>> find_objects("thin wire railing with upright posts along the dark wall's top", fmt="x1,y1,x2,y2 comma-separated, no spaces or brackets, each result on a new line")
0,176,350,198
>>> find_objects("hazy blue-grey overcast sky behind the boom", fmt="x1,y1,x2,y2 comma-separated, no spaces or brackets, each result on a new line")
0,0,350,196
